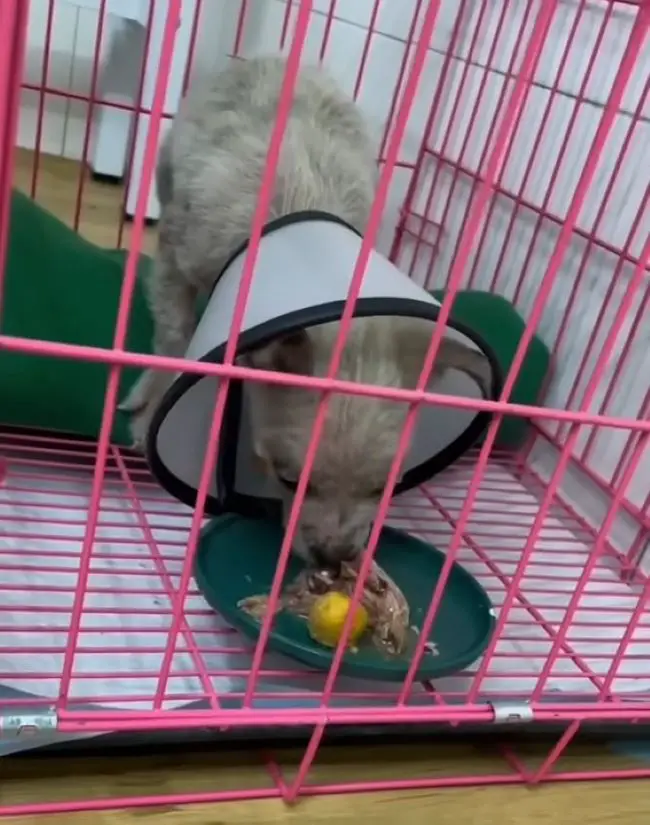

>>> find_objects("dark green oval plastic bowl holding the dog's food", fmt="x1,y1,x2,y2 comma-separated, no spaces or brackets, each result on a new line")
194,514,495,682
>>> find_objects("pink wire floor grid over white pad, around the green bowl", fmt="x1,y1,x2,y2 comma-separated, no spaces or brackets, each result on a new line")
0,424,650,710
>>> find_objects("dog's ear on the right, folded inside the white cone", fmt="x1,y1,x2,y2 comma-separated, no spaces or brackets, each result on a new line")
395,319,492,398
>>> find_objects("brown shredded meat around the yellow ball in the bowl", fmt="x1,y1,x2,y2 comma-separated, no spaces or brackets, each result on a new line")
239,562,410,655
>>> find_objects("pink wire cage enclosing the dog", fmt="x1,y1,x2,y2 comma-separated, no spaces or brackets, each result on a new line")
0,0,650,814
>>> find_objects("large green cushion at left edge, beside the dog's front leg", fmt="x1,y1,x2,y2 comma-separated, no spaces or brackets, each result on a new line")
0,191,153,445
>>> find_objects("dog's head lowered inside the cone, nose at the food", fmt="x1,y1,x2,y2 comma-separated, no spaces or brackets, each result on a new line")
243,318,489,567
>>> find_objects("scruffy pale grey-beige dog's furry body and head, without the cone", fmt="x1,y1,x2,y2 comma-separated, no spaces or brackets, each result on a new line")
122,53,487,565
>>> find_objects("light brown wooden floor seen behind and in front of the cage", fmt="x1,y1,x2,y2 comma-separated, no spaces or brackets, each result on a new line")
0,152,650,825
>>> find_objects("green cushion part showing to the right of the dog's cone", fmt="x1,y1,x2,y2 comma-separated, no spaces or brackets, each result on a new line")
431,290,551,450
